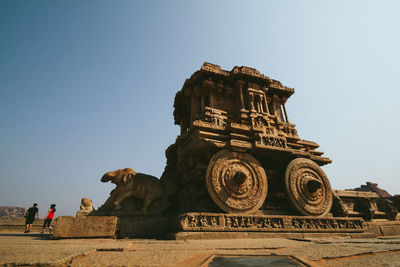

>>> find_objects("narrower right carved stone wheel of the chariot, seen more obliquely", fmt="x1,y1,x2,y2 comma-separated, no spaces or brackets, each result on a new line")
285,158,333,216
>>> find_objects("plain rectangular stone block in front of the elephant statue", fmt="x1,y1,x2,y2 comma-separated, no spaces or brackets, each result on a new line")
53,216,117,238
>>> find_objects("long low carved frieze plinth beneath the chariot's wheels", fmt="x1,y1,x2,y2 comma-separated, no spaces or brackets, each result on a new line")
171,215,365,233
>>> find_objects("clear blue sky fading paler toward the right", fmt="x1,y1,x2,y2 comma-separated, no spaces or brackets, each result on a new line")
0,0,400,217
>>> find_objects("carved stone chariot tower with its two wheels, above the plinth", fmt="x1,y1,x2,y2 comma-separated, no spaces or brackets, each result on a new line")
169,63,333,216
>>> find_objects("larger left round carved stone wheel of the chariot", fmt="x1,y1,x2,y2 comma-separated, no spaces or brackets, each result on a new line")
206,149,268,213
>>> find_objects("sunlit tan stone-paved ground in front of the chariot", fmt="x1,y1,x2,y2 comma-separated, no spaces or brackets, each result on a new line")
0,232,400,266
